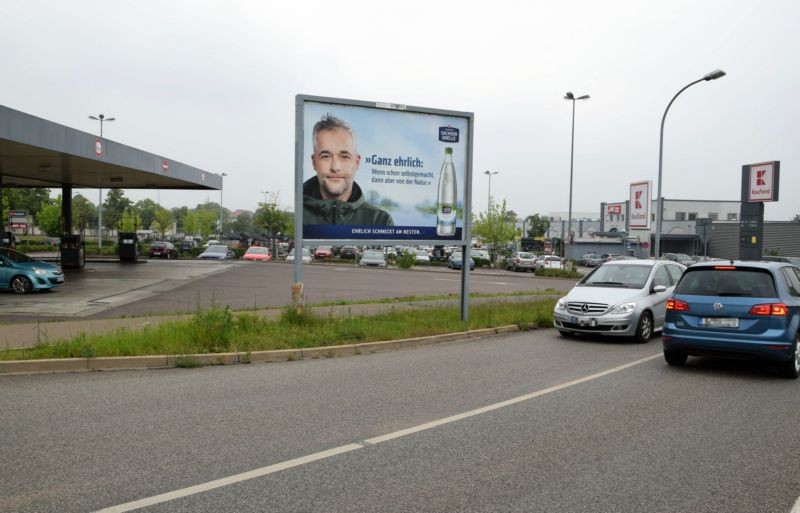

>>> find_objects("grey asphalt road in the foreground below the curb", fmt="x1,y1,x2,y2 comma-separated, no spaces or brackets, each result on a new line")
0,330,800,513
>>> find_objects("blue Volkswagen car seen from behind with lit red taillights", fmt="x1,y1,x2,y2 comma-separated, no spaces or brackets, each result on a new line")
662,261,800,379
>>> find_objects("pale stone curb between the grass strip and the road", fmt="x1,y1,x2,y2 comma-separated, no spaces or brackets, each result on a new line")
0,325,536,375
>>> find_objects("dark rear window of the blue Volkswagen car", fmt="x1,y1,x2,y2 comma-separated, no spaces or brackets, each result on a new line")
675,266,777,297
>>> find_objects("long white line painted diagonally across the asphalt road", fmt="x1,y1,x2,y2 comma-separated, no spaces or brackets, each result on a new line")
96,353,656,513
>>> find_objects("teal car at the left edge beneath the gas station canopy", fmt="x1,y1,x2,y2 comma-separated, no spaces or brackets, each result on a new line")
0,248,64,294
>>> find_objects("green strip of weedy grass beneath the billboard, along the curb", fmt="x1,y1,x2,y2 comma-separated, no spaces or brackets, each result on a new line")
0,298,555,360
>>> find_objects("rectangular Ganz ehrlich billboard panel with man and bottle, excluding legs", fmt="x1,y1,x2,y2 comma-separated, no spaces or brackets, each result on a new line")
295,95,473,242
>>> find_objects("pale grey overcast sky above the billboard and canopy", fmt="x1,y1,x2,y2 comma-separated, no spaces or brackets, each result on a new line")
0,0,800,220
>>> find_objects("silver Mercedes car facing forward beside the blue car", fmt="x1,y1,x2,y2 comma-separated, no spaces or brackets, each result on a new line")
553,260,686,342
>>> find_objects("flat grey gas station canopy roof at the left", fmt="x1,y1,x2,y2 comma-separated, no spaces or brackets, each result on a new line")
0,105,222,190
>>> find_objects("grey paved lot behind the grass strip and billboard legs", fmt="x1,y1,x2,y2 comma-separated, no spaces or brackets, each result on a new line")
0,259,574,323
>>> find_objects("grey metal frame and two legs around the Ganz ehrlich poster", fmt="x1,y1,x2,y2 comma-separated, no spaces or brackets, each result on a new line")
292,94,475,320
